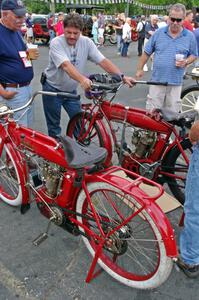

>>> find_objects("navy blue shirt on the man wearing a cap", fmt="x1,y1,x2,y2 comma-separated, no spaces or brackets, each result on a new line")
0,24,33,83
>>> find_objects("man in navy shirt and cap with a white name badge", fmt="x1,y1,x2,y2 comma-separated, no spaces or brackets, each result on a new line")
0,0,38,126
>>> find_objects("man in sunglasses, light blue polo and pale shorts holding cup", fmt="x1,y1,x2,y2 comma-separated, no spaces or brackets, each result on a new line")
136,3,197,120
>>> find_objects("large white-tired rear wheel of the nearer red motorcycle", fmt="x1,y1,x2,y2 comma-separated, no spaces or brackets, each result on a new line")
76,183,172,289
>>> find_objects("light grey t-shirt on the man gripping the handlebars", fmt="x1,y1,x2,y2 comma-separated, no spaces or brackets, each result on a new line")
45,35,105,92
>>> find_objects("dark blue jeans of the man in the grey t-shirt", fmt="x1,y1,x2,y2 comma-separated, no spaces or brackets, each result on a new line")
42,81,81,137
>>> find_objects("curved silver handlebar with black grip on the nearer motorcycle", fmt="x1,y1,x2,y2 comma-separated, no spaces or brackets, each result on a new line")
0,91,80,116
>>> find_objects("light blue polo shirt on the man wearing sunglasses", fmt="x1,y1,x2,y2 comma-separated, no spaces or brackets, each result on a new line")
144,26,198,85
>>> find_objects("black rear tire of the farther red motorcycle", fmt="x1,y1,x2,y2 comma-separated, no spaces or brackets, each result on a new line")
163,138,192,205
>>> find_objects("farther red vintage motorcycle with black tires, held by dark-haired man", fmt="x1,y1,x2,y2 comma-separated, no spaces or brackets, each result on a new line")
67,74,192,204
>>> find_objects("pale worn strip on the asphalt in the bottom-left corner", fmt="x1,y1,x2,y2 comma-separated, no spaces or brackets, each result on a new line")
0,261,36,300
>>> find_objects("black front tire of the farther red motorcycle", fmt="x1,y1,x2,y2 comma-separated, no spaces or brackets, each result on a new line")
66,112,104,147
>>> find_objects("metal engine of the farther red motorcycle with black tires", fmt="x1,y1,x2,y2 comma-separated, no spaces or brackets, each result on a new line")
131,129,157,158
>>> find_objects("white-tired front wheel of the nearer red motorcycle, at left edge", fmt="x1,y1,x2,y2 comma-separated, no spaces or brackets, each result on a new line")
0,145,22,206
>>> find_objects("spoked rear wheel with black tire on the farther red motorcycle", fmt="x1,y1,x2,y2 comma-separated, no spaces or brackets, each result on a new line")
163,139,192,204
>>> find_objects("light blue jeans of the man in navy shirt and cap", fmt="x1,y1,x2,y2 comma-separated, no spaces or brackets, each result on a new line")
0,85,33,127
